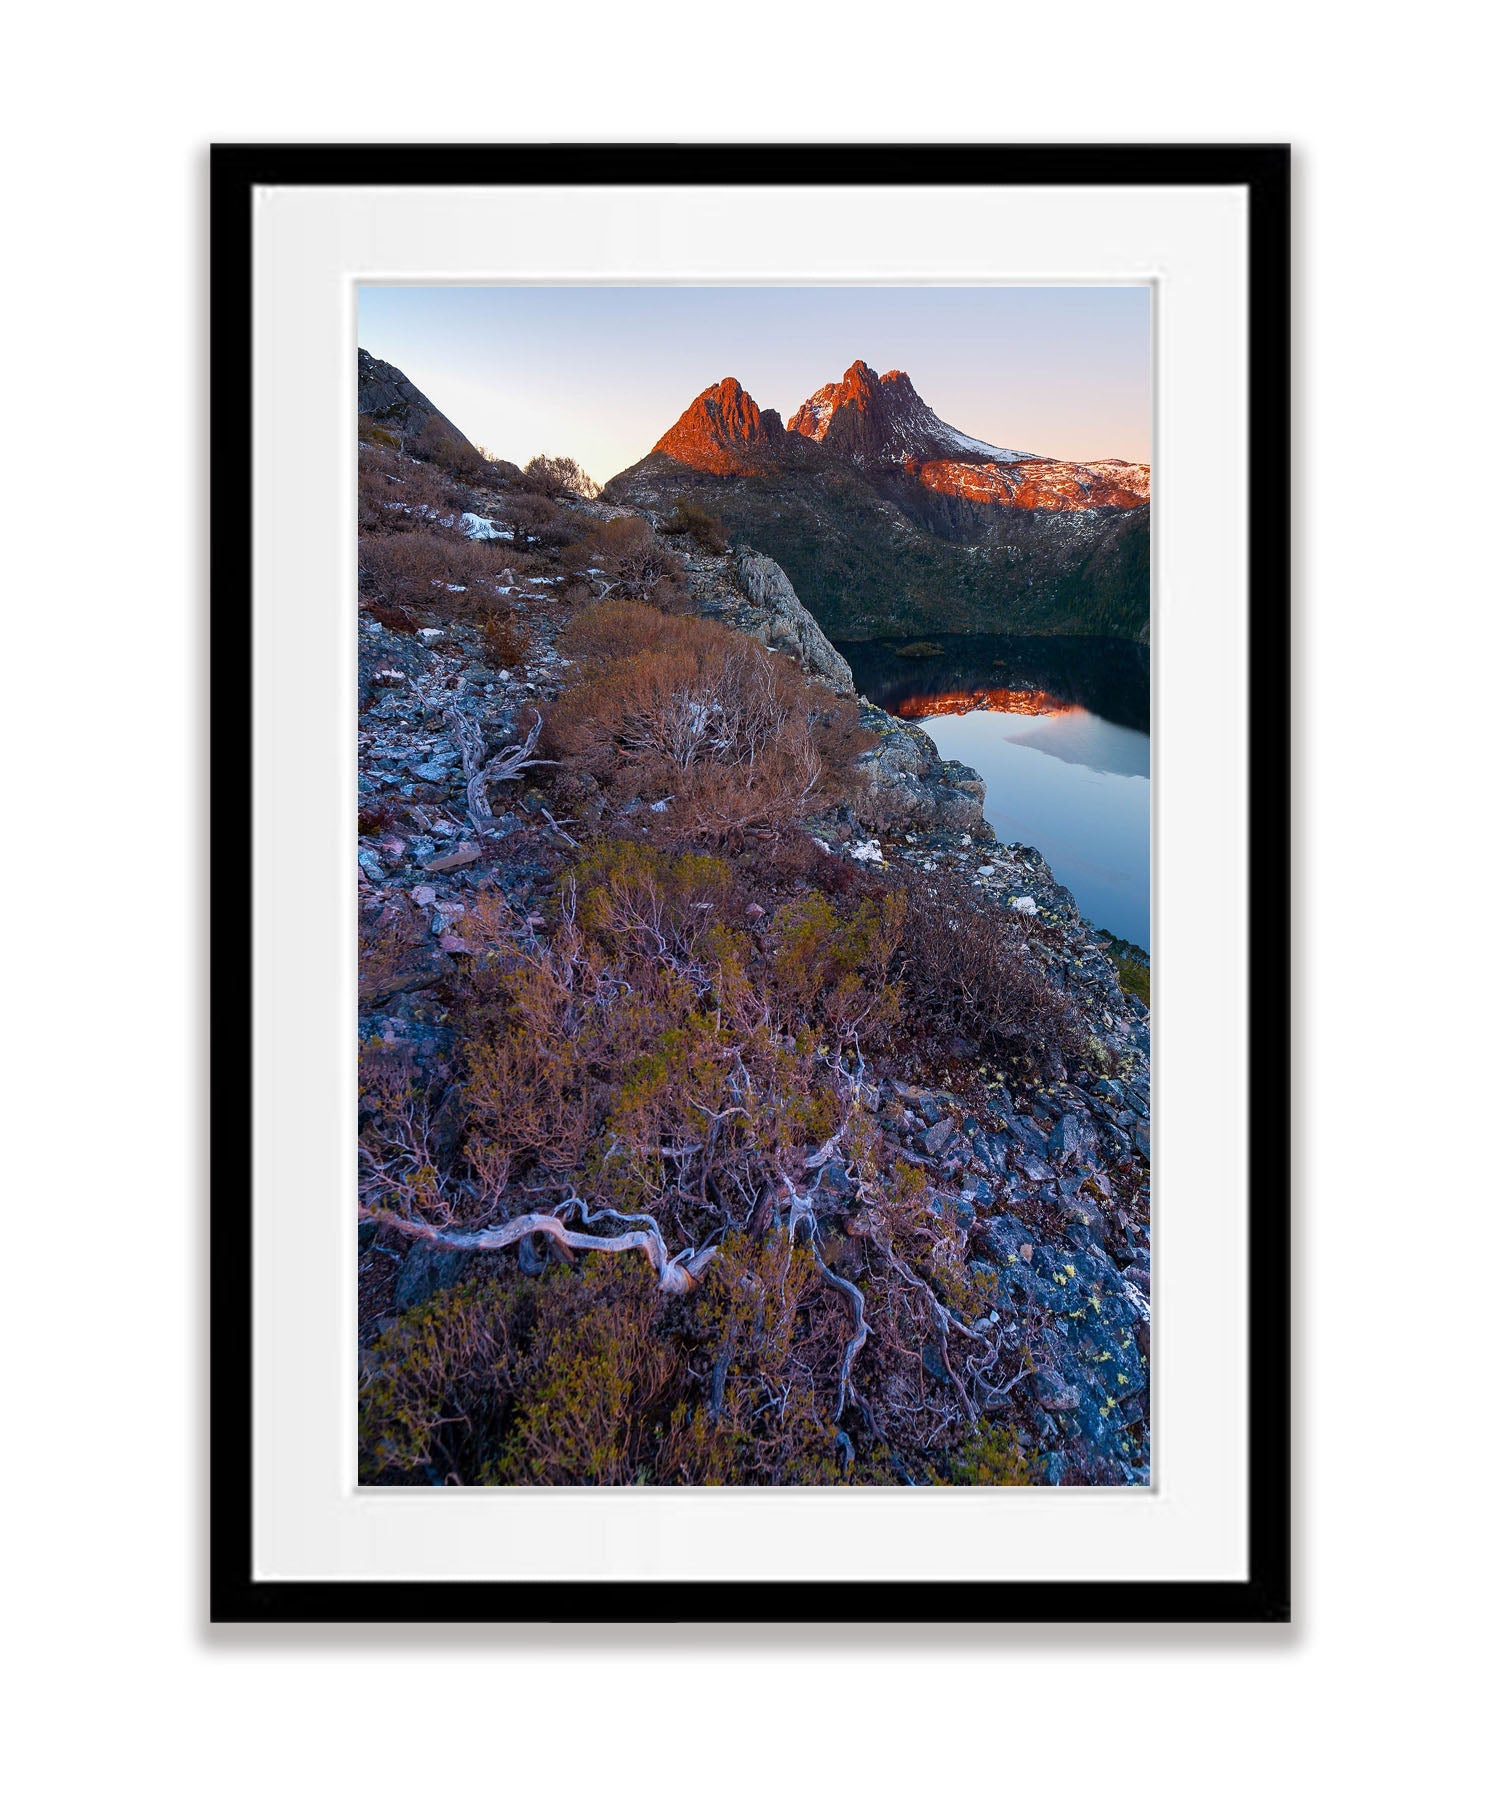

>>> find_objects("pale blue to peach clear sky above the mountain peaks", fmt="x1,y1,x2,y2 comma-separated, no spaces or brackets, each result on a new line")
360,286,1151,481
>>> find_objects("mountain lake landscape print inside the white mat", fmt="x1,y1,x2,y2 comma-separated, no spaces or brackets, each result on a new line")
348,283,1152,1487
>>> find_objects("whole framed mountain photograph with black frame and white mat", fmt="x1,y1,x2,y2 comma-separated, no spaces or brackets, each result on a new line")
211,144,1291,1624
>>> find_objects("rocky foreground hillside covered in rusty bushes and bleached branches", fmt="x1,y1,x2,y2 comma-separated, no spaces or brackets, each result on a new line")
358,401,1151,1483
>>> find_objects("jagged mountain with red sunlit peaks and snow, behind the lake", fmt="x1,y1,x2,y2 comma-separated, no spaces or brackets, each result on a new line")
607,362,1151,641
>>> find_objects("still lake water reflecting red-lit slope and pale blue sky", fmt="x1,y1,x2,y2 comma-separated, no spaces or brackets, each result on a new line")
837,637,1151,949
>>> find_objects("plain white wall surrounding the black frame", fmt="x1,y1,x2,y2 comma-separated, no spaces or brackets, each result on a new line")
0,0,1496,1800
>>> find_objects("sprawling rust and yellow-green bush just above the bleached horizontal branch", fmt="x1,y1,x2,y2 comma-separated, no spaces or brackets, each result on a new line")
454,841,897,1229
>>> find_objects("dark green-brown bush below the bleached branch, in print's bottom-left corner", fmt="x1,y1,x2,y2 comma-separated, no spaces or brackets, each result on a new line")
360,1233,864,1487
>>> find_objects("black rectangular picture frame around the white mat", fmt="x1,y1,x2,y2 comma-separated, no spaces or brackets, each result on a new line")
209,144,1291,1624
